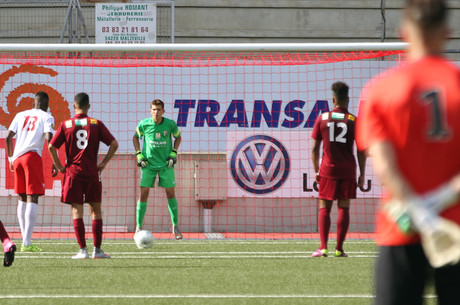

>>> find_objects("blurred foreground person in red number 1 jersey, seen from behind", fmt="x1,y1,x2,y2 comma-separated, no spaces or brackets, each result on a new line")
357,0,460,305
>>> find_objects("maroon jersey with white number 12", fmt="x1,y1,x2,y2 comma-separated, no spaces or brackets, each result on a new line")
311,107,356,179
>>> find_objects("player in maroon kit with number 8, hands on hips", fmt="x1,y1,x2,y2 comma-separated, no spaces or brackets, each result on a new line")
49,93,118,259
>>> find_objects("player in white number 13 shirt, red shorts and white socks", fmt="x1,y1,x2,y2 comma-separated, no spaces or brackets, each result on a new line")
6,91,56,252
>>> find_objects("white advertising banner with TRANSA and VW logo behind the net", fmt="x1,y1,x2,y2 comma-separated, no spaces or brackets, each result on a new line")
0,61,390,197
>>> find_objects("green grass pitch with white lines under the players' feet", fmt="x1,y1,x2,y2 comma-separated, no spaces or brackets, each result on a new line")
0,240,435,305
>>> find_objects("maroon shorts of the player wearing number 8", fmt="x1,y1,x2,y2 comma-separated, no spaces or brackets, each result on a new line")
61,173,102,204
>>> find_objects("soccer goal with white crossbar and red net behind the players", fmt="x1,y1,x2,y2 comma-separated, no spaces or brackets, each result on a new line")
0,44,404,239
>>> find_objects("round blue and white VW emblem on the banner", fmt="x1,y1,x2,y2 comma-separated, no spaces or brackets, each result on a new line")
230,135,291,194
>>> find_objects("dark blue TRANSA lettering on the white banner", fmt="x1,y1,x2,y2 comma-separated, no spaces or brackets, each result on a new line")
174,99,329,129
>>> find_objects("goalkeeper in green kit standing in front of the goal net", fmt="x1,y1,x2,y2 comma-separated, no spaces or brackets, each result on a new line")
133,99,183,239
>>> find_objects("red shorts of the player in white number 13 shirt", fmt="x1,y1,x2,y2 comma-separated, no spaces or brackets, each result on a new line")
13,152,45,195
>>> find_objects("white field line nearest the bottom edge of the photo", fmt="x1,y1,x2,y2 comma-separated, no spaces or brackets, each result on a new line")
0,294,436,299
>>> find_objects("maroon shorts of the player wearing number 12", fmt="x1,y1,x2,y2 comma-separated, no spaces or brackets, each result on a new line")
318,177,357,200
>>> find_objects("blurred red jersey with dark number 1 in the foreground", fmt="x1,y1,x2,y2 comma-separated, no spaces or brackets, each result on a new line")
357,56,460,246
